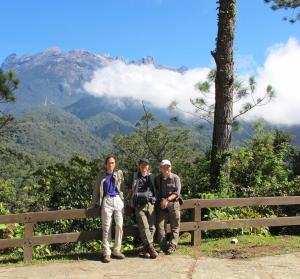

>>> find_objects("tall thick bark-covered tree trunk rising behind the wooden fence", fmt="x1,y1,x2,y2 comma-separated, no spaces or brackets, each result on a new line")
210,0,236,187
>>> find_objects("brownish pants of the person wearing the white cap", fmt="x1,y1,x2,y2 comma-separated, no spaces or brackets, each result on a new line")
158,201,180,249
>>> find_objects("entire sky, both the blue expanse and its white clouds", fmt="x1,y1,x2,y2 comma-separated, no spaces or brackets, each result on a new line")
0,0,300,124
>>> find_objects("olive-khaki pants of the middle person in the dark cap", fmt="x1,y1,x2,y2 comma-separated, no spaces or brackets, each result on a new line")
135,202,156,246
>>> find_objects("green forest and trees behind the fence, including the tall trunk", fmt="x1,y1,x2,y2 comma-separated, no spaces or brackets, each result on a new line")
0,1,300,262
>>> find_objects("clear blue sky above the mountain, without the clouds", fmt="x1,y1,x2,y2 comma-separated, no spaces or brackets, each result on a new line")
0,0,300,68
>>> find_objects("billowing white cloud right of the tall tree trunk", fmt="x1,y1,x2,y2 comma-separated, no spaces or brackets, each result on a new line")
247,38,300,125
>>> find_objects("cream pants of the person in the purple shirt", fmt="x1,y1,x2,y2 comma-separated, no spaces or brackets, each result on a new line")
101,196,124,255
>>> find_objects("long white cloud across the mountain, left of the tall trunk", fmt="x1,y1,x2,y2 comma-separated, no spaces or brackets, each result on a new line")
84,60,209,113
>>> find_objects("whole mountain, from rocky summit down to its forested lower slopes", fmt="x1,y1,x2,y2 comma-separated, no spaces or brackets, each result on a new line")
0,48,300,162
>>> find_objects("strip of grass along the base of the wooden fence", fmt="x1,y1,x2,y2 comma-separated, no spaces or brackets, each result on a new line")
0,233,300,265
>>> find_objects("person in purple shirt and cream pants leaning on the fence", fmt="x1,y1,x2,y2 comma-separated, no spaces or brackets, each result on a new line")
92,155,125,263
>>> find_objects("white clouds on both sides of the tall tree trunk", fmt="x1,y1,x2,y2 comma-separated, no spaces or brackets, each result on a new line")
85,38,300,124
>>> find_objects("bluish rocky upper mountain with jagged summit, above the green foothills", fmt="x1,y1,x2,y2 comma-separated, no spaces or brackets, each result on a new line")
1,48,185,112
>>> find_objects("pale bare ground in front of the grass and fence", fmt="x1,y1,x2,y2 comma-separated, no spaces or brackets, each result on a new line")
0,252,300,279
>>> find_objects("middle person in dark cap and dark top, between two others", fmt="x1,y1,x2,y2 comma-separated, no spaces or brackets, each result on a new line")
130,158,158,259
